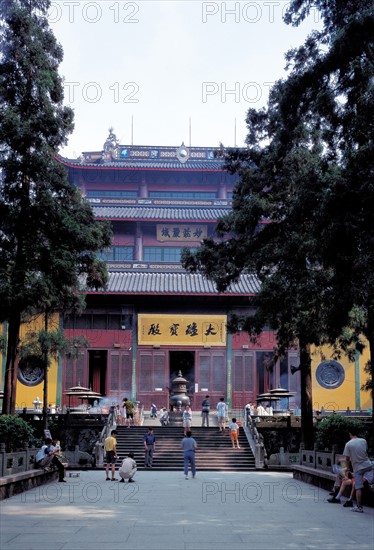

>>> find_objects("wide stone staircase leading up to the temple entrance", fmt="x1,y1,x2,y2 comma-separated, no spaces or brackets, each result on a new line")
117,426,255,472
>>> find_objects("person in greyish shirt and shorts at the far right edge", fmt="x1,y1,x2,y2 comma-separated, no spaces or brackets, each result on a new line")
343,427,373,513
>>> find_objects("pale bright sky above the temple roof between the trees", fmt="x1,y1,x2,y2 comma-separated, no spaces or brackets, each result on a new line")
48,0,321,158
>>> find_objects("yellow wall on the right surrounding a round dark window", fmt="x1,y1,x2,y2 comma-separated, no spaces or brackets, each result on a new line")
312,346,371,410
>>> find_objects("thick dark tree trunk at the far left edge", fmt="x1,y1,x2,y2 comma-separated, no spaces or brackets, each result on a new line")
3,311,21,414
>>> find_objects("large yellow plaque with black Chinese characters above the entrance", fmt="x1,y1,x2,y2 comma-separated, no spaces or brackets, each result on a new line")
138,313,227,346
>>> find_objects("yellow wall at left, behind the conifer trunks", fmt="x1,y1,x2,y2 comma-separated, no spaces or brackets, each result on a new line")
0,315,58,409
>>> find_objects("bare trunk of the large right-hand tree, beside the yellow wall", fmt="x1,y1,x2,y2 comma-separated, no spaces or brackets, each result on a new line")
299,340,314,449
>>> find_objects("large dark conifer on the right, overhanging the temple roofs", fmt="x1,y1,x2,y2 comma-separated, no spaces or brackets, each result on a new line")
184,0,374,446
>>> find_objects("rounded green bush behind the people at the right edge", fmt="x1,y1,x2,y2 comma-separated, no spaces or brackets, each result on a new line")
316,414,364,453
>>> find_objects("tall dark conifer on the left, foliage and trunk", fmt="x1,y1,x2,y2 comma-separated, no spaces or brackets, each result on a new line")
0,0,110,414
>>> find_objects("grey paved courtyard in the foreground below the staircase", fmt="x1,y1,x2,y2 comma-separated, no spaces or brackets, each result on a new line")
0,470,374,550
